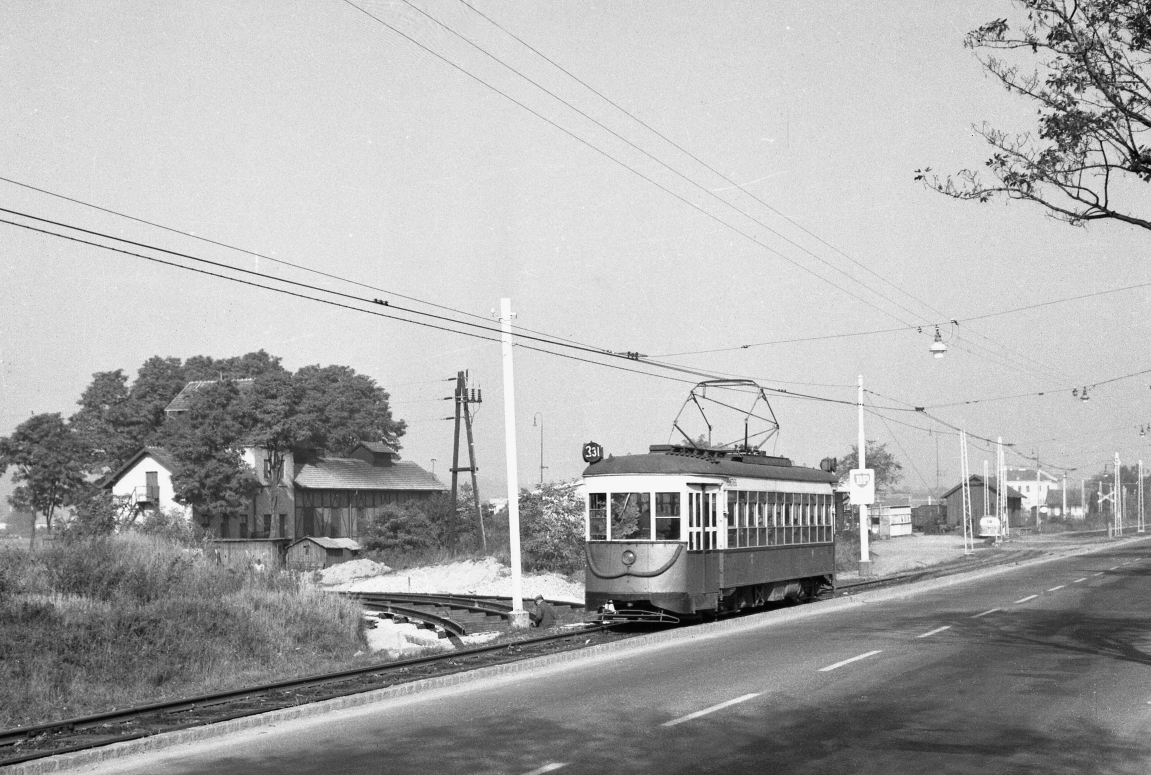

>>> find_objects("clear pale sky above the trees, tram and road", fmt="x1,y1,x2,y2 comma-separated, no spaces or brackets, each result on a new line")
0,0,1151,497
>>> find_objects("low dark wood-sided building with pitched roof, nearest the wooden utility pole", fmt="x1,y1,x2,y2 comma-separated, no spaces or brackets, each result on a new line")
294,441,448,538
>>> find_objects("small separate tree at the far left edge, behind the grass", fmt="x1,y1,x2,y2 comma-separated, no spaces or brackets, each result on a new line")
0,413,86,545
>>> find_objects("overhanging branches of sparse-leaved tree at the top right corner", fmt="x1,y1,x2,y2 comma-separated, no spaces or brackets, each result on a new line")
916,0,1151,229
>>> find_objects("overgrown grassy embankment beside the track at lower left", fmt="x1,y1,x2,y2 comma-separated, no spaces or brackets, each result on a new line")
0,534,365,729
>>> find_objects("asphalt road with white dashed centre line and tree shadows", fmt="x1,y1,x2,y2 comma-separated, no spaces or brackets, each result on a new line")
78,541,1151,775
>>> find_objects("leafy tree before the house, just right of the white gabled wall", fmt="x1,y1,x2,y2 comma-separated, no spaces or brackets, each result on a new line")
165,380,260,532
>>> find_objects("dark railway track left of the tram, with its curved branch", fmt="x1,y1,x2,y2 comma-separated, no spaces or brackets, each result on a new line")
0,595,616,767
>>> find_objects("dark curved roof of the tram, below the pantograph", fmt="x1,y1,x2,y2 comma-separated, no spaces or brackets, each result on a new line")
584,445,839,484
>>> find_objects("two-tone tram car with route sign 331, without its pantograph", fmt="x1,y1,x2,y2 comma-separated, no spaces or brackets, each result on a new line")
584,443,839,622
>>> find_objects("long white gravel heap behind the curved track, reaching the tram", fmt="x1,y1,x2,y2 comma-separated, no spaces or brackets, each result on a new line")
322,557,584,603
